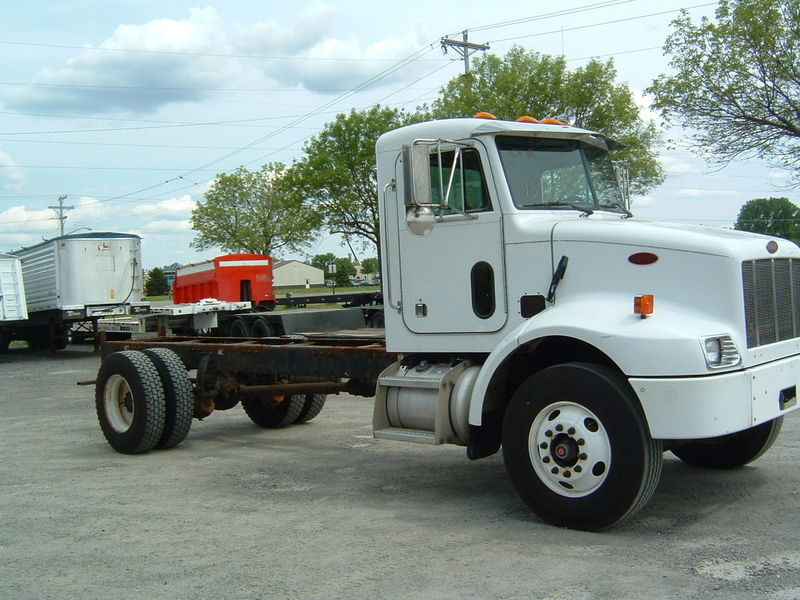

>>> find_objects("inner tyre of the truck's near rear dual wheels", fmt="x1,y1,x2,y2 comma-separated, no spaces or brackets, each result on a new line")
144,348,194,449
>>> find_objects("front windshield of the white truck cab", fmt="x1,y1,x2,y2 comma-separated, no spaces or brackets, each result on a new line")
497,136,623,212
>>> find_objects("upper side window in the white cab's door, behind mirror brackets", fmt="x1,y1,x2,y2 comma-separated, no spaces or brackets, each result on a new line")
430,148,492,216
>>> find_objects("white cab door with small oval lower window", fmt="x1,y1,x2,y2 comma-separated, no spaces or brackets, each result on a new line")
398,145,506,333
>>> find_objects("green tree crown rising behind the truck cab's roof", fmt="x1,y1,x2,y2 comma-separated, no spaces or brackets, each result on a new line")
431,46,664,194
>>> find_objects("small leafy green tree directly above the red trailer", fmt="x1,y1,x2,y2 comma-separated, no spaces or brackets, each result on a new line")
191,163,319,255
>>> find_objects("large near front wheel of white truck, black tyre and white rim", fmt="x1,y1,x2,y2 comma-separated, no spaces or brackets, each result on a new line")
502,363,662,531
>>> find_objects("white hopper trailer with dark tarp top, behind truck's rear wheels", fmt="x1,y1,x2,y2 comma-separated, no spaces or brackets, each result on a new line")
0,232,149,352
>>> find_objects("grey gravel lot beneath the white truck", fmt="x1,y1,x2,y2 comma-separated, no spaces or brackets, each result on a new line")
0,346,800,600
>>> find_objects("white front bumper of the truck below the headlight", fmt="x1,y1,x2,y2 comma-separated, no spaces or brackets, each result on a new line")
629,355,800,439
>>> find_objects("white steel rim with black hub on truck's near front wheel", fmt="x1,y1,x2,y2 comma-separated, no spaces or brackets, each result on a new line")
528,402,611,498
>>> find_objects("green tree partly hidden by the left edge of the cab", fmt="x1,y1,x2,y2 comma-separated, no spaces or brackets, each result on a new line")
286,106,415,255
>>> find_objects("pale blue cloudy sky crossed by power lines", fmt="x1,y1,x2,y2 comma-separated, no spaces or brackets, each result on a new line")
0,0,800,268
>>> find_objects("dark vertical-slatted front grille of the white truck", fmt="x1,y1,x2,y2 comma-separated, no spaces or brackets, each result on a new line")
742,258,800,348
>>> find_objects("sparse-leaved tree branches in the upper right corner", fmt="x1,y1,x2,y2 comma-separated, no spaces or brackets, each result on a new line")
647,0,800,185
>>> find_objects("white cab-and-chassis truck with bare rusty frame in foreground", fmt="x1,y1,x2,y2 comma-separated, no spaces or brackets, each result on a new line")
90,118,800,530
